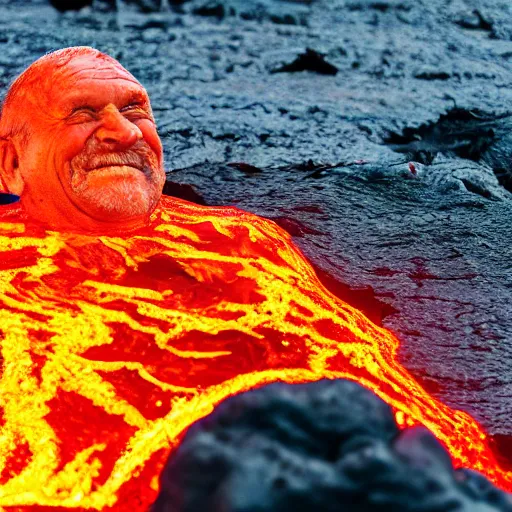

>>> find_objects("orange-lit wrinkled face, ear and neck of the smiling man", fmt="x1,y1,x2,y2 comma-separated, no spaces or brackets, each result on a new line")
0,49,165,232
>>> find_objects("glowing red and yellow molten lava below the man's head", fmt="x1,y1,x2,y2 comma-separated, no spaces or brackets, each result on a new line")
0,198,512,511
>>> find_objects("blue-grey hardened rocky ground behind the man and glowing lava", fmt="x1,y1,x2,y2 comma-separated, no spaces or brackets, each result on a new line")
0,0,512,464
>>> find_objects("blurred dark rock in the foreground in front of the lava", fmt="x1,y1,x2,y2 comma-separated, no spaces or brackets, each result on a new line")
151,380,512,512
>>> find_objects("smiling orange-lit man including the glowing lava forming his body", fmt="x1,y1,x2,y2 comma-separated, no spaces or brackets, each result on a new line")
0,47,510,511
